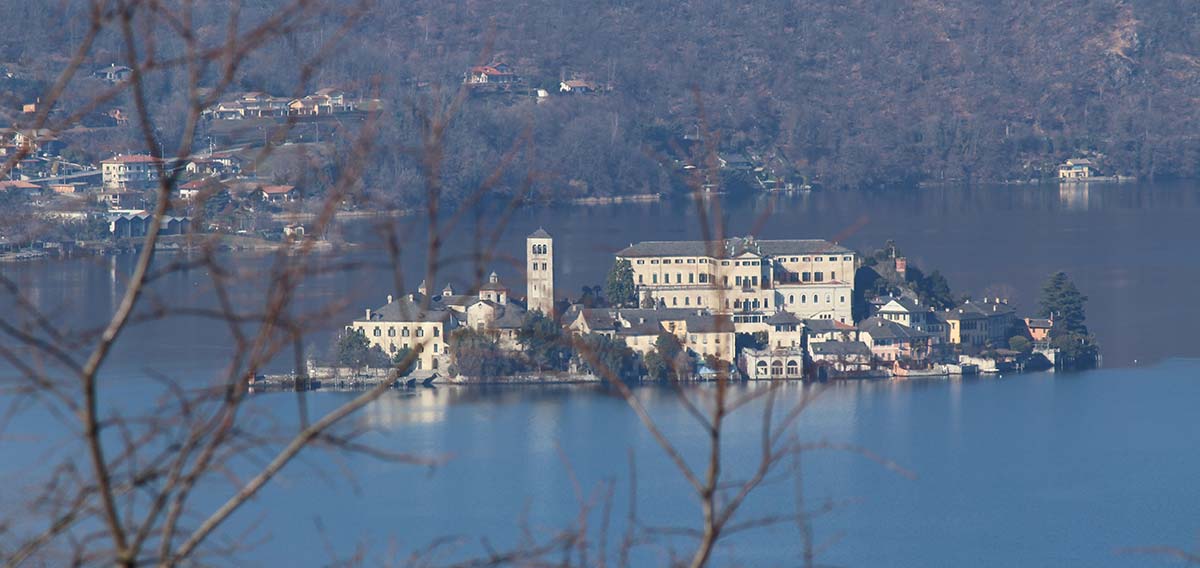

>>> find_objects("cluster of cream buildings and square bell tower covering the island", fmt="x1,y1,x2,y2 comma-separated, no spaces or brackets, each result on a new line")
347,229,1054,379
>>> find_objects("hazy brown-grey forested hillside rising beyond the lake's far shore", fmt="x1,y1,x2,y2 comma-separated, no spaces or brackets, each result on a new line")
0,0,1200,202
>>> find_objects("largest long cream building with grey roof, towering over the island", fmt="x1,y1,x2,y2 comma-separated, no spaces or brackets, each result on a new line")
617,237,857,333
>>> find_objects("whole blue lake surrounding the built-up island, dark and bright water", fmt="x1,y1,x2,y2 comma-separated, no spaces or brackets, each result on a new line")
0,183,1200,566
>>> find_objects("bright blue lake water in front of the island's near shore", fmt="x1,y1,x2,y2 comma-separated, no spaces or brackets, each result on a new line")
211,359,1200,567
